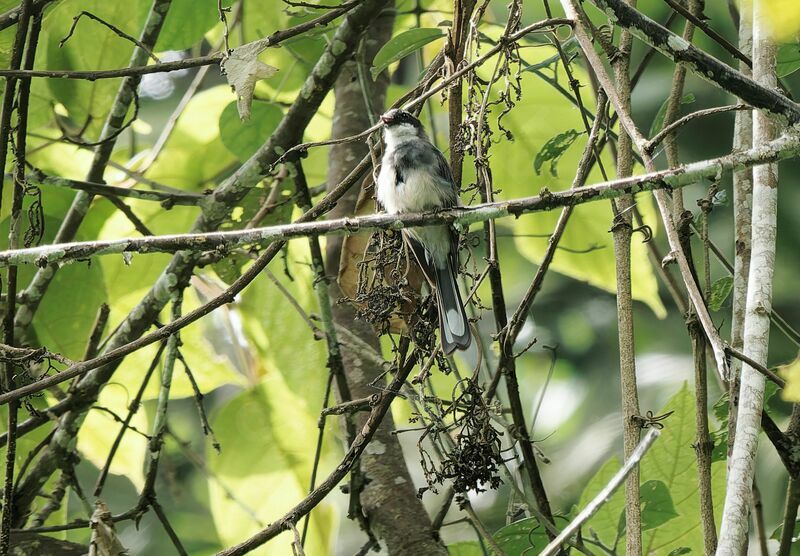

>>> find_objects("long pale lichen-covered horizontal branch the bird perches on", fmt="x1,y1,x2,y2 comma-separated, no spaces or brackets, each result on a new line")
0,135,800,268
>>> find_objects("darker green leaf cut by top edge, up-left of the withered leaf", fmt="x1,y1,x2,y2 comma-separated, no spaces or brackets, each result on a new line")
156,0,233,52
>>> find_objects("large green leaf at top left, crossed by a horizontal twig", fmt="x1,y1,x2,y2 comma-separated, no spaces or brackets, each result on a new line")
37,0,152,138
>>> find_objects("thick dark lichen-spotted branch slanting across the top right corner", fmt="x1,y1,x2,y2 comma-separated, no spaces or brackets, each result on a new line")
593,0,800,124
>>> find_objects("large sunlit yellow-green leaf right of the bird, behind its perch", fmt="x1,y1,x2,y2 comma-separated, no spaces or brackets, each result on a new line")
482,47,666,316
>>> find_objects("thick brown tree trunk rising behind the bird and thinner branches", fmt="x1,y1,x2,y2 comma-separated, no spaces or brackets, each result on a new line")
327,3,447,555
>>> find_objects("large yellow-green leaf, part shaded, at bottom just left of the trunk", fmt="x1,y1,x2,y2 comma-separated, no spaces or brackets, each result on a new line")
206,373,336,555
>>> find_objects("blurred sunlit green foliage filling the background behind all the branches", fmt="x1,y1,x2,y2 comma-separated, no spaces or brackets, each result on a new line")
0,0,800,555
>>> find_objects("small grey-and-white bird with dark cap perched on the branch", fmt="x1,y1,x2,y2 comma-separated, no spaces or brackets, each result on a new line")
377,108,471,355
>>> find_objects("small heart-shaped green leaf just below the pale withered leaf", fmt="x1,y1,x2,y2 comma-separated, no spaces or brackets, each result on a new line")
219,102,283,161
